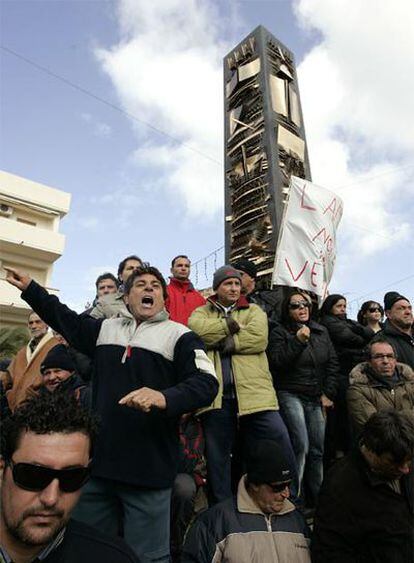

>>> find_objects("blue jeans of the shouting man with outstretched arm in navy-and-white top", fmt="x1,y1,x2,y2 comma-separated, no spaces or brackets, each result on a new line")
72,477,171,563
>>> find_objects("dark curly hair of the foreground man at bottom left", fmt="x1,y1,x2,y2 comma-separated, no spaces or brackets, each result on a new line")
1,391,98,460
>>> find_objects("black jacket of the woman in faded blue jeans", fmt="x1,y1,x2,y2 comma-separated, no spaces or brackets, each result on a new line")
267,321,339,400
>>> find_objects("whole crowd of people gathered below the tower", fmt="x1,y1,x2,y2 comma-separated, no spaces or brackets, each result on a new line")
0,255,414,563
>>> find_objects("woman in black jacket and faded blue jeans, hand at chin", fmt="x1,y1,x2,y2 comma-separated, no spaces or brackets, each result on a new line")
268,288,339,507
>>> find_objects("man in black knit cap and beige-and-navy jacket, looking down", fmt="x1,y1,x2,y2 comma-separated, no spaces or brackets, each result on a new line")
181,440,310,563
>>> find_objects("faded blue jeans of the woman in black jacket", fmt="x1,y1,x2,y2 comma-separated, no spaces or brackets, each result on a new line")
277,391,325,504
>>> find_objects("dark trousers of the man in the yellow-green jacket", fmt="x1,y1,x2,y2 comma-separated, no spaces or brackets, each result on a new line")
202,399,296,505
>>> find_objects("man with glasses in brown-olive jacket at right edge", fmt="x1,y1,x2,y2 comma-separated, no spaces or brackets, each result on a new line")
347,335,414,435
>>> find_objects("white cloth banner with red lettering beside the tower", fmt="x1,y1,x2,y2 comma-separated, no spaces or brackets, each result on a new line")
272,176,343,299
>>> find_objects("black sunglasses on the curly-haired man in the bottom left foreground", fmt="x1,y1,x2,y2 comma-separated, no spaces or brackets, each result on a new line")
8,460,91,493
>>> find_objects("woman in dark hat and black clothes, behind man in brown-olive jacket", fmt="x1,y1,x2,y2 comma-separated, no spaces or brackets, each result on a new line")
320,294,375,461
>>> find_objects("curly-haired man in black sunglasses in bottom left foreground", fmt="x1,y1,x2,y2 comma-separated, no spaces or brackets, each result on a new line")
0,394,137,563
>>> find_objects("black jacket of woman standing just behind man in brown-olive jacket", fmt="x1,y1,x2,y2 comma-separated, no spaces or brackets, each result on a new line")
320,314,375,378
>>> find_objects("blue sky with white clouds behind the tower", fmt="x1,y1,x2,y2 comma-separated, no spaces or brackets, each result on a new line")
0,0,414,314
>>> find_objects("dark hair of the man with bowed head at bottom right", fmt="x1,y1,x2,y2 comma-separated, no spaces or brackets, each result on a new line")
361,409,414,463
